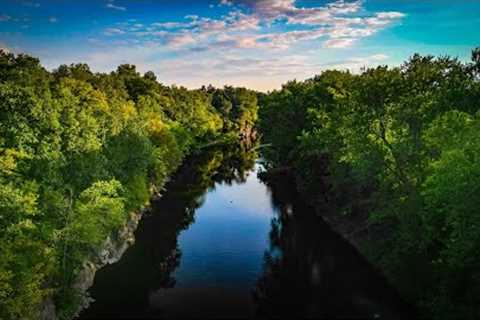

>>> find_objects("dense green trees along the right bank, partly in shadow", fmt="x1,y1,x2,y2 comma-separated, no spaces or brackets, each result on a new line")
259,49,480,319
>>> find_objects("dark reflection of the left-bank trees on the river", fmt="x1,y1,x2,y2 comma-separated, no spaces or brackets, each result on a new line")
80,146,260,319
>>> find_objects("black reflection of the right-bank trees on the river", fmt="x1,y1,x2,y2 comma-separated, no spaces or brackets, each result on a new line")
255,175,414,319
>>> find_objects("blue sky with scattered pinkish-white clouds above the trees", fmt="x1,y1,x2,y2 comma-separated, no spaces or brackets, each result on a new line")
0,0,480,91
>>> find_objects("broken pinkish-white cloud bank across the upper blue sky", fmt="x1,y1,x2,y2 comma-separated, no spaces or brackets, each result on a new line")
106,0,405,50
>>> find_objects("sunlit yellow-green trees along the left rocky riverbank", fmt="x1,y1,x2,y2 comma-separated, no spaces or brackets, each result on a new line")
0,51,257,319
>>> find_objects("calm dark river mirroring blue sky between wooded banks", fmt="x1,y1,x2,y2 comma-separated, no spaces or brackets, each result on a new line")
80,148,412,319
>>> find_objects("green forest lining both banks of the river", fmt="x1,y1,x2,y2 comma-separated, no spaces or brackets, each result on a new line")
0,48,480,319
